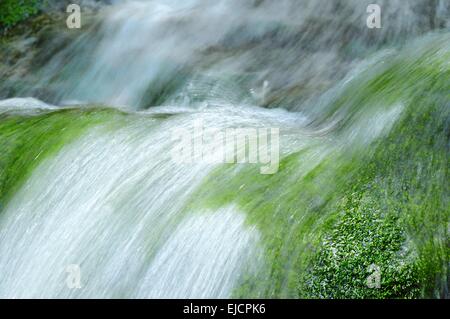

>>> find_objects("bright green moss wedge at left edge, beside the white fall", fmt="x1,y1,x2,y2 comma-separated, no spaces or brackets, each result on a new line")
0,109,125,210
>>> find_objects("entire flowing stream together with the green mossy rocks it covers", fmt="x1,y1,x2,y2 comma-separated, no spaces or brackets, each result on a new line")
0,0,450,298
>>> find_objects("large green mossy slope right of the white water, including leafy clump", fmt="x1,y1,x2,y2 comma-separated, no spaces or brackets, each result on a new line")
185,36,450,298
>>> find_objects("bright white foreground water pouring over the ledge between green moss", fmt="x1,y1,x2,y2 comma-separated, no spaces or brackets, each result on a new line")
0,108,298,298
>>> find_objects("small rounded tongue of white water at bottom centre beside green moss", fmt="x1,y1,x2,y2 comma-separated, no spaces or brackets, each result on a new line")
136,207,263,298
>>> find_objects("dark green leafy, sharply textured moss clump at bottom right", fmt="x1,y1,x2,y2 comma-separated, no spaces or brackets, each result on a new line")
300,192,421,298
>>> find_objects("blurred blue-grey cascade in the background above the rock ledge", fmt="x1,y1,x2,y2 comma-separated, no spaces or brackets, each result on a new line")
9,0,450,108
